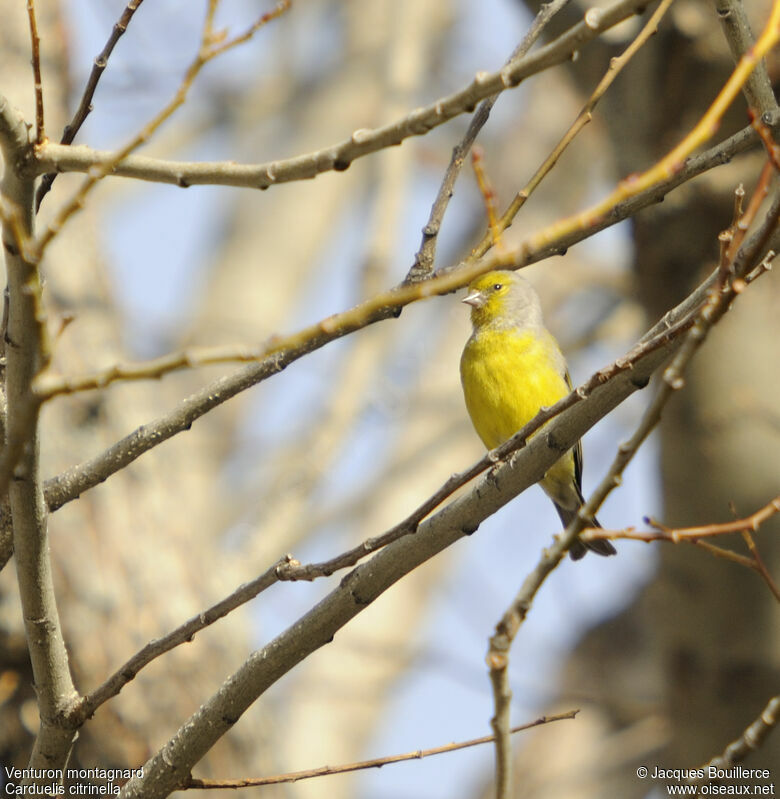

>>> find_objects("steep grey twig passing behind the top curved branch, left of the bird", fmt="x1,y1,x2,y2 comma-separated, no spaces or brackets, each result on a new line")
406,0,569,283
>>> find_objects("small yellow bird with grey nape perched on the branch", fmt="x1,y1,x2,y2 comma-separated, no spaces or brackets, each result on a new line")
460,271,615,560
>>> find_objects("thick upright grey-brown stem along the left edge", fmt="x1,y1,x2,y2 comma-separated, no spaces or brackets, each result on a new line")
0,98,77,787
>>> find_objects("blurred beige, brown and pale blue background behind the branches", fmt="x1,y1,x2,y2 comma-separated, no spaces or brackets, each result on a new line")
0,0,780,799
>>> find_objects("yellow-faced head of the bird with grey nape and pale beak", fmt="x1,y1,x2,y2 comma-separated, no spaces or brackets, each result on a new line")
463,271,542,329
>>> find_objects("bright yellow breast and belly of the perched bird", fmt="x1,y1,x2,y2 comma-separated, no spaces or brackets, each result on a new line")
460,328,569,449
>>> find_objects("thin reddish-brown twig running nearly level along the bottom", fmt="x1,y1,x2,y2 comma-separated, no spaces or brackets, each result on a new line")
184,710,579,790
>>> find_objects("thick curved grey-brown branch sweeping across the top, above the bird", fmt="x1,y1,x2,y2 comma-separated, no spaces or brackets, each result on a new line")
31,0,646,189
